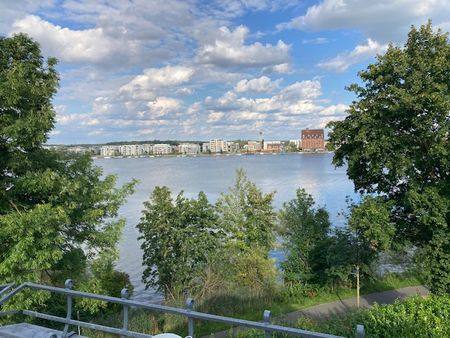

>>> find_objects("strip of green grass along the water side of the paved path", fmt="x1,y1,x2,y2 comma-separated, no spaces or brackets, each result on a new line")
82,273,423,338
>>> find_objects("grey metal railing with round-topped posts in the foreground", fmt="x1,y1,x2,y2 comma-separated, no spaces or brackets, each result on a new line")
0,279,364,338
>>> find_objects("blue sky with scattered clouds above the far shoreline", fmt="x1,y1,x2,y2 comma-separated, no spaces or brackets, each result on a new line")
0,0,450,144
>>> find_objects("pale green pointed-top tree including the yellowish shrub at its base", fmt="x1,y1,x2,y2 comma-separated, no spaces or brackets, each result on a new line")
210,169,277,297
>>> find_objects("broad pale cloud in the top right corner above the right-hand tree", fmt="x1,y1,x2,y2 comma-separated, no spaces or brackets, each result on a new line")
277,0,450,43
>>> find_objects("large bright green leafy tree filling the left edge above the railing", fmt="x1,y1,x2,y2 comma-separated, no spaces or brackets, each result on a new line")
0,34,133,308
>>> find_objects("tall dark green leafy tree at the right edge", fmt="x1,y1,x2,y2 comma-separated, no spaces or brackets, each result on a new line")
329,22,450,293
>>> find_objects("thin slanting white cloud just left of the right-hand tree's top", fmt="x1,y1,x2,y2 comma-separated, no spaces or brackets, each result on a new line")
317,39,387,72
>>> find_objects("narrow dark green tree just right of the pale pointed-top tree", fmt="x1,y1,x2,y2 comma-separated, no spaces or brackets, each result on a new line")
279,189,330,283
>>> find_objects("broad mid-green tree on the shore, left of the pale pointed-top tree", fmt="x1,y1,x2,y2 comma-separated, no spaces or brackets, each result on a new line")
137,187,221,300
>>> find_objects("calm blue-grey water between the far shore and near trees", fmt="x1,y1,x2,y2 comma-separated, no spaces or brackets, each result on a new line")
95,154,354,301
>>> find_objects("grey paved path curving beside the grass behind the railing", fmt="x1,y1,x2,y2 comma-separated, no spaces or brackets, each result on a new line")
208,286,429,338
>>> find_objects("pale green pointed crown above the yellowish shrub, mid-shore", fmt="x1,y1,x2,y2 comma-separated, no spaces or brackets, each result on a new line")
216,169,276,255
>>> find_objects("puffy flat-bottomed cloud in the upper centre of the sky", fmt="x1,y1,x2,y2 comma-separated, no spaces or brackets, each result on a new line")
196,26,290,67
